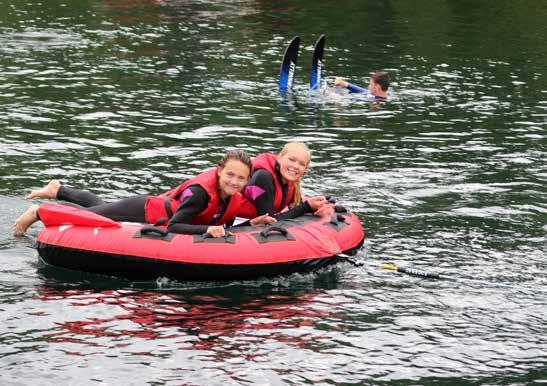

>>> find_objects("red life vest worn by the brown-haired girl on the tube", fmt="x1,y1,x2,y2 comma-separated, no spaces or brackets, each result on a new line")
144,168,243,225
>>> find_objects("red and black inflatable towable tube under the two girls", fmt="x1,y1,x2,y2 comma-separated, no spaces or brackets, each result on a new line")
36,204,364,281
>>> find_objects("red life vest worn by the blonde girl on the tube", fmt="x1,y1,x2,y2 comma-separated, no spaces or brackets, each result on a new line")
238,153,294,218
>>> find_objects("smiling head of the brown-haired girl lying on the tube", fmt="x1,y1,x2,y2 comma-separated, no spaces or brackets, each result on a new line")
217,149,252,198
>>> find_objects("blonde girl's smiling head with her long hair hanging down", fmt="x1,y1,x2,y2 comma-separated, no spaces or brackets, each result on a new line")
277,142,311,205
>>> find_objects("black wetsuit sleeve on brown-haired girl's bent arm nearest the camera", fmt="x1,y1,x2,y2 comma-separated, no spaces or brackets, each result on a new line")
167,185,209,234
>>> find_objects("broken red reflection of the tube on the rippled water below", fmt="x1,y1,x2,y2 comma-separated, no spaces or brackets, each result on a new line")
39,287,326,350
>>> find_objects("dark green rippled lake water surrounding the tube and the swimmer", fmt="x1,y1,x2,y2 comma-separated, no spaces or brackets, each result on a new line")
0,0,547,385
